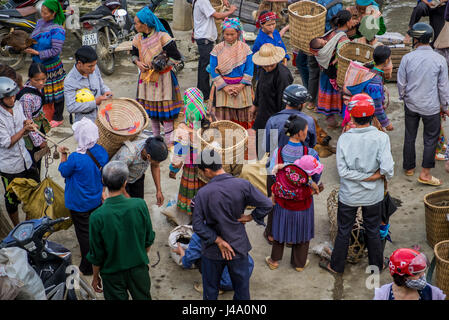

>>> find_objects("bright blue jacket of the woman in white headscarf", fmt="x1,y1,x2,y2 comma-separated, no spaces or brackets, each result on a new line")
58,144,109,212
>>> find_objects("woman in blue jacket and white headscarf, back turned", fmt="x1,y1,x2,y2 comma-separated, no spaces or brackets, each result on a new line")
58,117,109,275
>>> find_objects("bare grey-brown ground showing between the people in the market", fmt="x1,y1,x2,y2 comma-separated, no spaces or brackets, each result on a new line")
1,1,449,300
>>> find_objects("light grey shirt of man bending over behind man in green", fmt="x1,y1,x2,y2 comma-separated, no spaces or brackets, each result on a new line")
111,139,150,183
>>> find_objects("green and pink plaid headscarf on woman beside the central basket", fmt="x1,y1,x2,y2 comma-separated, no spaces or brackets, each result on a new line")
184,88,207,129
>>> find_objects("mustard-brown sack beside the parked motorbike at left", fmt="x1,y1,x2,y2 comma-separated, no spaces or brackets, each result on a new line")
6,177,72,231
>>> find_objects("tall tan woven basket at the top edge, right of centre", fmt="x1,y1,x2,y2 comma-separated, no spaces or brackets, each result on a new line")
288,0,327,54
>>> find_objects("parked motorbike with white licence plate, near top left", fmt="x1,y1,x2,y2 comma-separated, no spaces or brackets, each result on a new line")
78,0,184,75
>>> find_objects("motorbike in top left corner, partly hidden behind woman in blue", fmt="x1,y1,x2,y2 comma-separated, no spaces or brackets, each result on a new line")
0,0,73,70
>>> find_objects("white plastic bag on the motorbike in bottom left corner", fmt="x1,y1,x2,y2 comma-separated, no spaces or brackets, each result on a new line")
0,247,47,300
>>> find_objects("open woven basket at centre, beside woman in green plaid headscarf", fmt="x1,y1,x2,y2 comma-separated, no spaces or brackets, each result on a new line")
196,120,248,183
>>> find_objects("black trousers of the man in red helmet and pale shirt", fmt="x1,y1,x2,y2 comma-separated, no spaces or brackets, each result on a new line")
331,201,383,273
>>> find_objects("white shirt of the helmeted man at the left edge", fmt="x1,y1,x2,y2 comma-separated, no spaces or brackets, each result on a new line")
0,101,33,174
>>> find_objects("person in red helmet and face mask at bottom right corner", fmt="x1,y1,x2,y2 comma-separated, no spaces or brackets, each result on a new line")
374,248,446,300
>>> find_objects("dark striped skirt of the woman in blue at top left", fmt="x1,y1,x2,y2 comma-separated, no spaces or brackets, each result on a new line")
43,59,66,104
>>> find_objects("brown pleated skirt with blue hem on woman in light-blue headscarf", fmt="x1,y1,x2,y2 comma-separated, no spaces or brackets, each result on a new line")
137,71,184,121
